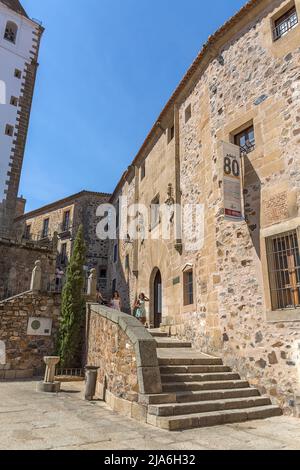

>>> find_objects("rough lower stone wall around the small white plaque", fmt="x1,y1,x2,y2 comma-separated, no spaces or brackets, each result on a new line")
0,292,61,379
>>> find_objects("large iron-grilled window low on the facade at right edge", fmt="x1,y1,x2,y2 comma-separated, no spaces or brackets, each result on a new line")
266,230,300,310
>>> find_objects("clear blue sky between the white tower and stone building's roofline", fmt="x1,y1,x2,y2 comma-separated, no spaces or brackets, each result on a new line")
20,0,245,210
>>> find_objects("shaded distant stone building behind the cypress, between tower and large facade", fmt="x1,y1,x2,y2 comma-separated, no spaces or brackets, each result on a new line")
14,191,110,295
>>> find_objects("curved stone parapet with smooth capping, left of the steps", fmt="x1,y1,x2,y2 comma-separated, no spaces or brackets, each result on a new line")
86,303,162,411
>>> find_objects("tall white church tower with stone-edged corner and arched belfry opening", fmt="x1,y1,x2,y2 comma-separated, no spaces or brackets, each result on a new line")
0,0,44,237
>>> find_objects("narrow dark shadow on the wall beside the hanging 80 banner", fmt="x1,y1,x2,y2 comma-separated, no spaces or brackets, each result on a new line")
244,153,261,259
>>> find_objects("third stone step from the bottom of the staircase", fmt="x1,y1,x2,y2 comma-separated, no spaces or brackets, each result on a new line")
140,388,260,405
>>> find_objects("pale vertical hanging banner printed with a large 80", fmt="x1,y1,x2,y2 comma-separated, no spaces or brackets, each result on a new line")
222,142,243,220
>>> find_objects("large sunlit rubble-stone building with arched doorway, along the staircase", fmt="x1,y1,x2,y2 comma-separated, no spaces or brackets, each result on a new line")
109,0,300,410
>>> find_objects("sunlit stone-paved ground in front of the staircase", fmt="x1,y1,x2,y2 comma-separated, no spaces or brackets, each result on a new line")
0,381,300,450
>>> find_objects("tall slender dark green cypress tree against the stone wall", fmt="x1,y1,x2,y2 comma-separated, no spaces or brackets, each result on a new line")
57,226,86,368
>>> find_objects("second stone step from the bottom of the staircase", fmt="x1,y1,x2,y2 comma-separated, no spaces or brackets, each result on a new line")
148,397,271,416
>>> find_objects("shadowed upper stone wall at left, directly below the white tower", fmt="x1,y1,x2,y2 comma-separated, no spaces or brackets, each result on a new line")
0,239,56,300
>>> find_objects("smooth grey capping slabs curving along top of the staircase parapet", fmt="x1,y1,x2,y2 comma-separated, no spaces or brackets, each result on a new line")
87,303,162,394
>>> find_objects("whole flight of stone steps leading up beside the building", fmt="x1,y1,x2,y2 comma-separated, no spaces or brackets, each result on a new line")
143,330,282,431
